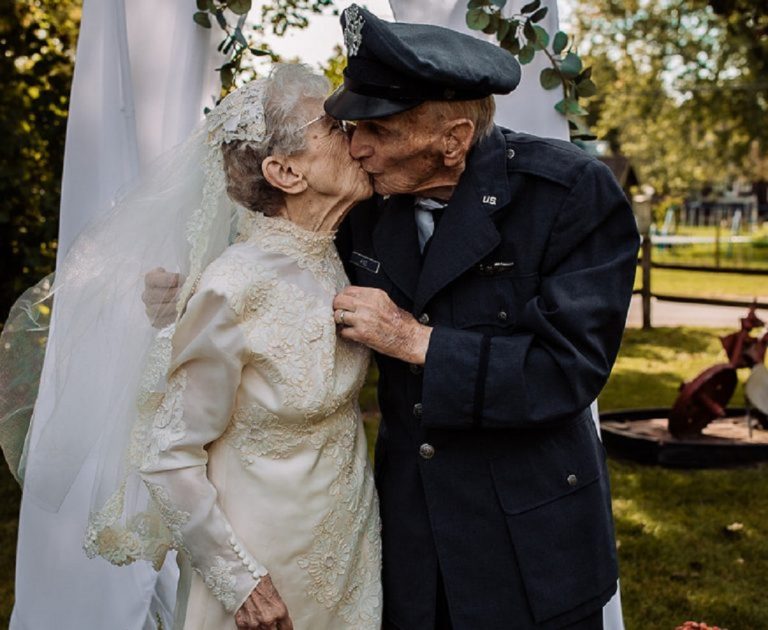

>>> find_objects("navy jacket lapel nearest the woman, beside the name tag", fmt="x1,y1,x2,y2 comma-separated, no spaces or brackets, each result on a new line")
373,195,421,300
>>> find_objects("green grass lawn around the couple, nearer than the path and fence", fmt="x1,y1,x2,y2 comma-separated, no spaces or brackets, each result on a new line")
0,328,768,630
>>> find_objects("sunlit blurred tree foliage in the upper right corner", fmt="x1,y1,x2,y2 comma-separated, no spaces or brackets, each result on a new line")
575,0,768,193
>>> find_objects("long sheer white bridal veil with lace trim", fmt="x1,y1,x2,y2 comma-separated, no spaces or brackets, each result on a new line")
12,79,269,566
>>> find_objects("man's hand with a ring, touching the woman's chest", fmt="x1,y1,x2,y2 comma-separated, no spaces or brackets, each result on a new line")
333,286,432,365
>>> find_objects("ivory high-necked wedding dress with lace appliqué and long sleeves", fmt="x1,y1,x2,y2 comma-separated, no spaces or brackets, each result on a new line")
123,214,382,630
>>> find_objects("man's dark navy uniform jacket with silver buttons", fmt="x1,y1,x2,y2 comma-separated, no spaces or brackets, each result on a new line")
338,127,639,630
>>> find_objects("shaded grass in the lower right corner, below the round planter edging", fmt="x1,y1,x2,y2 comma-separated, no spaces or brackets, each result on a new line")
610,460,768,630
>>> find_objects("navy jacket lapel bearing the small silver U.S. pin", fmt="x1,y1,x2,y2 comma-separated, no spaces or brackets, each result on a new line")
411,127,510,313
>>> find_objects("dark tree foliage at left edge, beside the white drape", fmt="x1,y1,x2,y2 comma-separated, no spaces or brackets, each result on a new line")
0,0,81,319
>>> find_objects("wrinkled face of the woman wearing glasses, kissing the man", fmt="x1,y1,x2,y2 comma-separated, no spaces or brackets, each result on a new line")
294,100,373,201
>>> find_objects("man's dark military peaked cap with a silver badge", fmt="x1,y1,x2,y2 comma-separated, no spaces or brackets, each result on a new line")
325,4,520,120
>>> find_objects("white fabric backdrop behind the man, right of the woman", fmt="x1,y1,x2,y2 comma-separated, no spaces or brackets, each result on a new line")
389,0,624,630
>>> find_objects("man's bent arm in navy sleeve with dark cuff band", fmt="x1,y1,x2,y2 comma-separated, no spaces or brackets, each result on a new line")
422,162,639,428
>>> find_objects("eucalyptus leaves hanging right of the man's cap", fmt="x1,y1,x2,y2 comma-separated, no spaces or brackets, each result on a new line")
467,0,597,140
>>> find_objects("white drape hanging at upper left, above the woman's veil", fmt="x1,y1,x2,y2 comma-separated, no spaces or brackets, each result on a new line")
58,0,218,259
